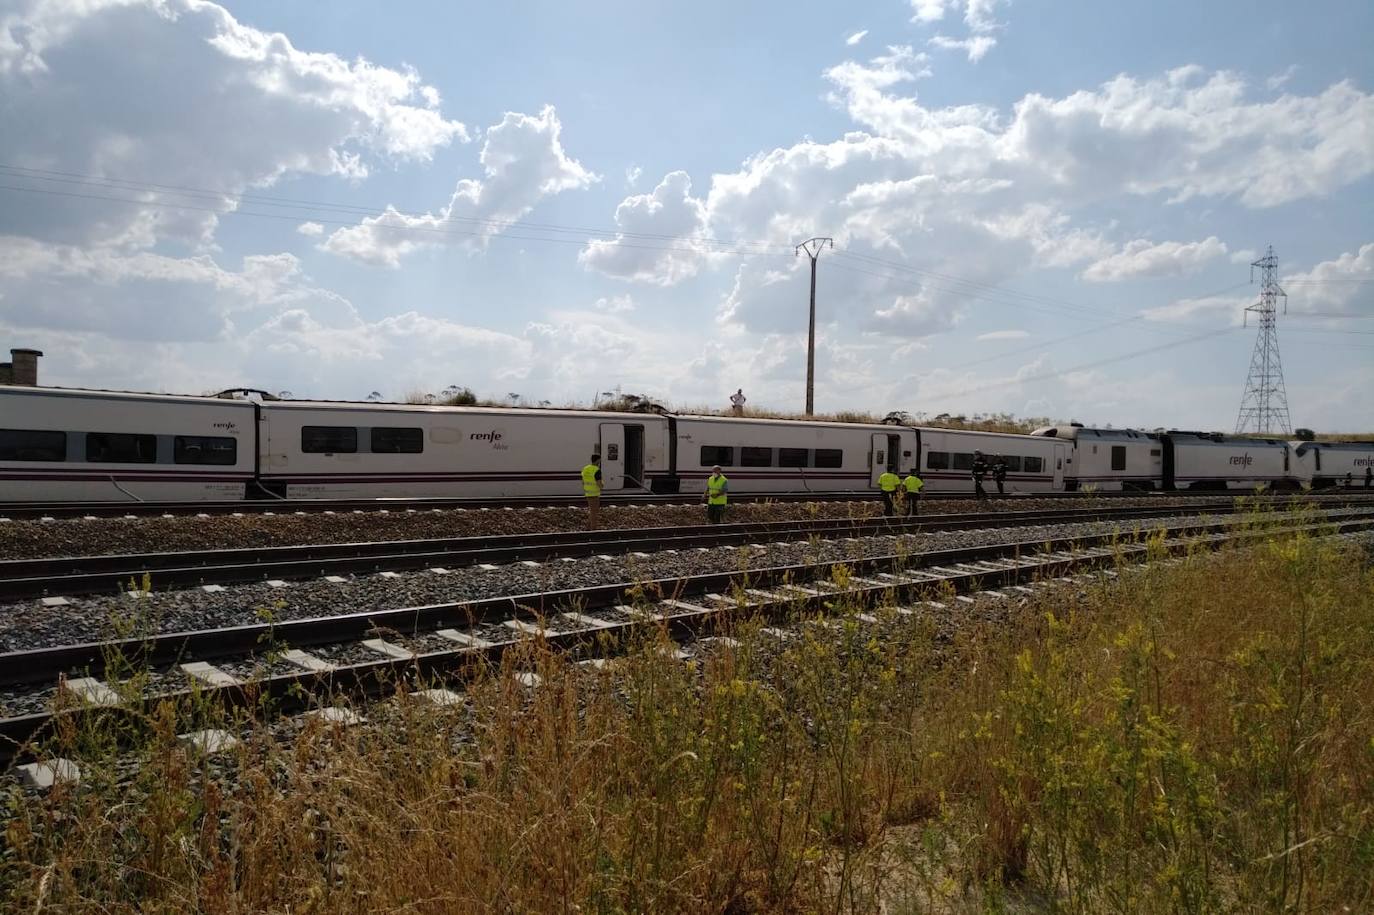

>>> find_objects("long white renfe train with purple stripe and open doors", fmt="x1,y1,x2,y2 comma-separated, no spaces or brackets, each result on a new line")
0,386,1374,501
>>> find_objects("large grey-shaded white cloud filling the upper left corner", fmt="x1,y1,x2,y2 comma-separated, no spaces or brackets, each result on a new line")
0,0,467,247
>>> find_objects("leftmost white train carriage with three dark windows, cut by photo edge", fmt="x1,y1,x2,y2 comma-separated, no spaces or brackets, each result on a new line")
0,387,257,501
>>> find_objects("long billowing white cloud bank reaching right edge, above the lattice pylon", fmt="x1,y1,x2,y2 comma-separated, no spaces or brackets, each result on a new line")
827,57,1374,207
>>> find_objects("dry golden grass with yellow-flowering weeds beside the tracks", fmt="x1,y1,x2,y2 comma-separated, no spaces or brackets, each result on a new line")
0,508,1374,914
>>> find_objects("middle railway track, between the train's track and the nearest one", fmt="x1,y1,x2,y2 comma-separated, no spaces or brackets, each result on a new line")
0,499,1258,602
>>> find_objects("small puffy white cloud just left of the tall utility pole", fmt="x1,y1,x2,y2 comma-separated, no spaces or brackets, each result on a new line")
577,172,710,286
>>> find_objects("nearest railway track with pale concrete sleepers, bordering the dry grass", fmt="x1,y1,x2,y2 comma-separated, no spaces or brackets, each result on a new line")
0,508,1374,763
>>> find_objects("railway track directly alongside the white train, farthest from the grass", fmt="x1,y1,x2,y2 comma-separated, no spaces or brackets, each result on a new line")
0,489,1351,521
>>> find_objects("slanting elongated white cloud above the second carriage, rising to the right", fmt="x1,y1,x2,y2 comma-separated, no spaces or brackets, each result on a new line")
322,104,600,268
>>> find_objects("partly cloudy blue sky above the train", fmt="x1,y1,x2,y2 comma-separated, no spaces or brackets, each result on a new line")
0,0,1374,431
